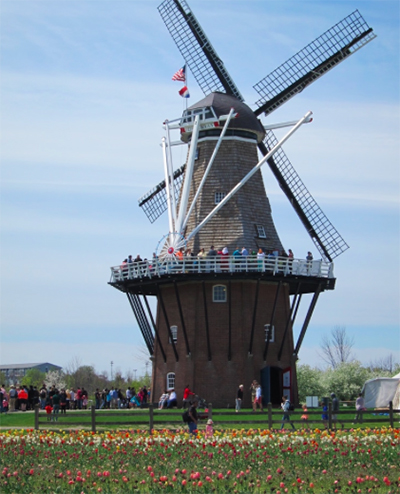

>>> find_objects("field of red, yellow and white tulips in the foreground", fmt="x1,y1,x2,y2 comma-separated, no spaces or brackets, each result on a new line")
0,428,400,494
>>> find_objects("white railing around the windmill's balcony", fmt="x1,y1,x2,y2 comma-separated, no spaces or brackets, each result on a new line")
110,255,334,283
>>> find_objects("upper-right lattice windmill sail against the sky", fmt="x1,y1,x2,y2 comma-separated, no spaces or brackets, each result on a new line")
253,10,376,115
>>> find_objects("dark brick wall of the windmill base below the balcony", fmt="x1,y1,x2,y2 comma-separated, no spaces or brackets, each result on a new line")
153,280,297,407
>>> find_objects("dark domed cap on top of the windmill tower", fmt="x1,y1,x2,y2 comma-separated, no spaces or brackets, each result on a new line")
182,92,265,142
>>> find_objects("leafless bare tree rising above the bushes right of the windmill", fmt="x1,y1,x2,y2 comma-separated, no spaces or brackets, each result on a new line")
319,326,354,369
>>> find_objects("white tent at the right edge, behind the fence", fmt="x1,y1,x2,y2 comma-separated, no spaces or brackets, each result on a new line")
362,374,400,410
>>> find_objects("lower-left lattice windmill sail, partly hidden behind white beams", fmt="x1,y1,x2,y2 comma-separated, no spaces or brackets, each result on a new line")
139,165,186,223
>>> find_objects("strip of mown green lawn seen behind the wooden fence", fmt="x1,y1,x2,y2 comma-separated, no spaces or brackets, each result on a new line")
0,408,398,430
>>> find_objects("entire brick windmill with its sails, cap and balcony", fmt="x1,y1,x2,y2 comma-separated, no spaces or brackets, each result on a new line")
110,0,375,406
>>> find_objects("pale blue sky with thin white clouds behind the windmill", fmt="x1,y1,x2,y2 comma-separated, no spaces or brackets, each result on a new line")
0,0,400,378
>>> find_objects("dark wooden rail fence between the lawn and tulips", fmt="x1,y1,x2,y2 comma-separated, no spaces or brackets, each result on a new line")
35,402,400,434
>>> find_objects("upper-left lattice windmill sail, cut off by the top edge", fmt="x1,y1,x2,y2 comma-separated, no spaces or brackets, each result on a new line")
158,0,243,101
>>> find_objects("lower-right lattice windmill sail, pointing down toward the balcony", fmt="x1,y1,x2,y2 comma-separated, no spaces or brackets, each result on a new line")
259,130,349,262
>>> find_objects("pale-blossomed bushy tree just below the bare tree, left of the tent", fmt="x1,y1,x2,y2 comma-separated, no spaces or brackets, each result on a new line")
321,360,370,401
